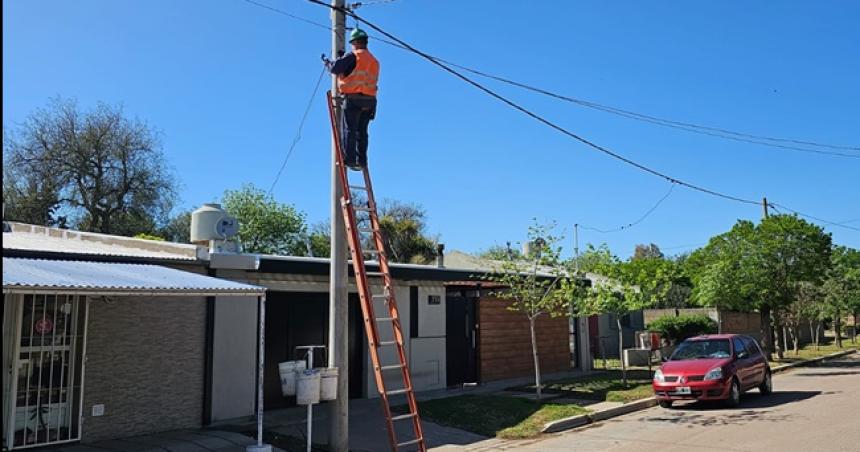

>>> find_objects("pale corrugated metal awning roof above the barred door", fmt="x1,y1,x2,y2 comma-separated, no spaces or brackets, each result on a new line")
3,257,266,296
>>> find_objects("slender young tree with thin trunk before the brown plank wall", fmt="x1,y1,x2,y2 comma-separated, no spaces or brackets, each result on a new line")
487,223,571,399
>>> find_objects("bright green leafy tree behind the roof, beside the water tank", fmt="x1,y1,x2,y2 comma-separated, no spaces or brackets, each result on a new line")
222,184,307,256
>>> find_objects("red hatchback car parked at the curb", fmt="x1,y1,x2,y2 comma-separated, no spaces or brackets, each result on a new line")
652,334,773,408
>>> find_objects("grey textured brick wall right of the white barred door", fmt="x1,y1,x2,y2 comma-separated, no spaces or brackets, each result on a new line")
82,297,206,442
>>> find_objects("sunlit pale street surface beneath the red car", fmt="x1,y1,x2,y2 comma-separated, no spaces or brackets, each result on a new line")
444,353,860,452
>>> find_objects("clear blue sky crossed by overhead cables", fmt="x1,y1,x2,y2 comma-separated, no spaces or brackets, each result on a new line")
3,0,860,256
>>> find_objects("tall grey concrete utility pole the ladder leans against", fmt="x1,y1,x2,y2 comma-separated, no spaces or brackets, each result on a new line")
328,0,349,452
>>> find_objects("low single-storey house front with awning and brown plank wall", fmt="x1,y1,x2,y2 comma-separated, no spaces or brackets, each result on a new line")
3,223,587,449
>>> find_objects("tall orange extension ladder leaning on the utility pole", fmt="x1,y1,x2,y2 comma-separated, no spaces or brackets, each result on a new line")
326,91,427,452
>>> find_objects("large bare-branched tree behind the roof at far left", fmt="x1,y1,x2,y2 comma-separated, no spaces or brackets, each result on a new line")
3,98,176,235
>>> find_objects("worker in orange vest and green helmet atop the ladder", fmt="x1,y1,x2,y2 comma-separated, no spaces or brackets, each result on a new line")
326,27,379,170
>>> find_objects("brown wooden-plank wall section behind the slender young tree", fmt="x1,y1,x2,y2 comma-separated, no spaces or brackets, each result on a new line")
478,297,570,382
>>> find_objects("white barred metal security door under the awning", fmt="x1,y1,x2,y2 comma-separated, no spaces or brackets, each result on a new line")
4,294,88,449
